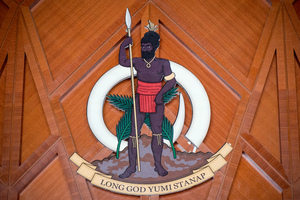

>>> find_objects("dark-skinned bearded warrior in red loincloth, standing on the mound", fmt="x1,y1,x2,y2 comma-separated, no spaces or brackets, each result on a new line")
119,21,176,178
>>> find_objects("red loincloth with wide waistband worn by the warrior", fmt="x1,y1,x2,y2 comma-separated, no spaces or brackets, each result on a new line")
137,80,162,113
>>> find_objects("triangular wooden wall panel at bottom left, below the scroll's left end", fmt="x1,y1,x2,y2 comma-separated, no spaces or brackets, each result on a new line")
8,140,80,199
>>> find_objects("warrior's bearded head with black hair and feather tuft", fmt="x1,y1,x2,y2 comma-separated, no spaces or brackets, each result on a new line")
141,20,160,59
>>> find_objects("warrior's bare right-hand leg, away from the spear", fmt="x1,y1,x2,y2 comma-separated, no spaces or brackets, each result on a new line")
150,104,168,176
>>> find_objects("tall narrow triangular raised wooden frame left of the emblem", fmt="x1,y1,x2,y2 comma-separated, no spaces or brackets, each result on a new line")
10,7,64,186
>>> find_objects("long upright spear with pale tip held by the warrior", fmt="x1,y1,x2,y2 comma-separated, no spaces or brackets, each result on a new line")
125,8,141,172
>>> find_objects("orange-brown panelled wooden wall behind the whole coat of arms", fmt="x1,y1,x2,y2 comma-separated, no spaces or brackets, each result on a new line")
0,0,300,200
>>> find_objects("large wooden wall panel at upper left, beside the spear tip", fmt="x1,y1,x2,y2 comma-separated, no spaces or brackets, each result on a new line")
32,0,145,92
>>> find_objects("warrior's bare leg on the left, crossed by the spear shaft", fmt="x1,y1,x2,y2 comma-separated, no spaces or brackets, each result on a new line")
119,94,146,178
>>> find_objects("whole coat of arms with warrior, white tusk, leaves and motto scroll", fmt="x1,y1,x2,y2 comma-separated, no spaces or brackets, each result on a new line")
70,9,232,195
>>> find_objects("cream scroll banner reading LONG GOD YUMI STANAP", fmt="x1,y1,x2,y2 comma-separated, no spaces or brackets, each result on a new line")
70,143,232,196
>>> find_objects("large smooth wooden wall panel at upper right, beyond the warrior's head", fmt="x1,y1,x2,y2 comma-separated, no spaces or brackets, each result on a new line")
155,0,270,89
